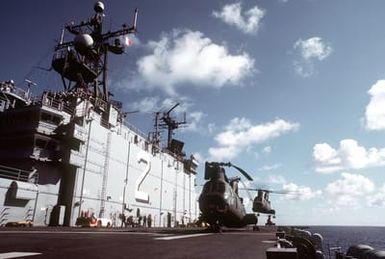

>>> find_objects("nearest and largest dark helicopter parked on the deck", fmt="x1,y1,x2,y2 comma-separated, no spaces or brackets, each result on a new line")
199,162,258,232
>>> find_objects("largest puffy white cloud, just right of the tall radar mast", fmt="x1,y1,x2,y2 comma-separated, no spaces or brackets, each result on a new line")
133,30,255,95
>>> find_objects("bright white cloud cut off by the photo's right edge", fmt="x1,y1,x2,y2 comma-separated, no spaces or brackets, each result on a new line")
365,80,385,130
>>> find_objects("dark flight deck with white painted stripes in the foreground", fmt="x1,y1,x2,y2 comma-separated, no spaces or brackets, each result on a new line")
0,227,276,259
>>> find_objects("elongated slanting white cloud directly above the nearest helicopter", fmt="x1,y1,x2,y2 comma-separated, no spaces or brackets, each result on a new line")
209,118,299,161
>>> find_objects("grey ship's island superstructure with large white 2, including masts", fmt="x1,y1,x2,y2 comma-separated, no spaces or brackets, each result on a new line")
0,2,198,229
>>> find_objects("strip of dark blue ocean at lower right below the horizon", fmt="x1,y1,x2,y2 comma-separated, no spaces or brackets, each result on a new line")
307,226,385,258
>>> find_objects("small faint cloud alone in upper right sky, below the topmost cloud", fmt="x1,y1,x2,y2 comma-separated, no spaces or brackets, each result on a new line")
293,37,333,77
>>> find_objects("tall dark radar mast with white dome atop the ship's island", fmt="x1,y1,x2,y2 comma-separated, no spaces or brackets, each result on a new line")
52,1,138,110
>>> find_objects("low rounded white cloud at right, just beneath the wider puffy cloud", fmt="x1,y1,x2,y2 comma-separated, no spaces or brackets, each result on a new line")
326,173,375,206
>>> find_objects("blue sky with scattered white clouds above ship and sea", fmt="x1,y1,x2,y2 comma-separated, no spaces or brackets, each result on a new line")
0,0,385,225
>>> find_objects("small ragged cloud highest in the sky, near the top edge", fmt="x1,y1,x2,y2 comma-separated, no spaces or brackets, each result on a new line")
213,3,266,34
